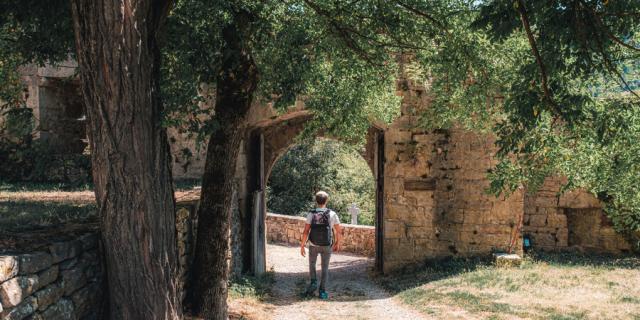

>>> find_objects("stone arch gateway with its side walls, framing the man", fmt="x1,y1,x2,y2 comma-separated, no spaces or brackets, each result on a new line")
230,83,524,273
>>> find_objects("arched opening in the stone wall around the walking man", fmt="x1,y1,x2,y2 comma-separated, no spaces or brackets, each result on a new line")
265,138,376,298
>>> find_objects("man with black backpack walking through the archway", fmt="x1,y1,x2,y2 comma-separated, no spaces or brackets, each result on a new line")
300,191,342,299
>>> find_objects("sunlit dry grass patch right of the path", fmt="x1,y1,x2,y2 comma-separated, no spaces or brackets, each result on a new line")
379,253,640,320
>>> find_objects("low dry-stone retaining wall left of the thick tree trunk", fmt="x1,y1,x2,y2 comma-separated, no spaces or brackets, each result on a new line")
0,233,104,320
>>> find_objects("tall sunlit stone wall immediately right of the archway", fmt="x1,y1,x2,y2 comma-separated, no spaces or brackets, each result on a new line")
383,78,524,272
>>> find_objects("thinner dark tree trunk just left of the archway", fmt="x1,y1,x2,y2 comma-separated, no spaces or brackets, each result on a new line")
190,13,257,320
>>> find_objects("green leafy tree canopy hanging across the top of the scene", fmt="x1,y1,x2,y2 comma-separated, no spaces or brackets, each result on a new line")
0,0,640,244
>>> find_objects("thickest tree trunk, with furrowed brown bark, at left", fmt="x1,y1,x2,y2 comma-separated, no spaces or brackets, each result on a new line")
71,0,182,320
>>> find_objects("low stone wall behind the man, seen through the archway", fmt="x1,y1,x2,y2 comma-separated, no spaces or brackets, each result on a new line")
267,213,376,257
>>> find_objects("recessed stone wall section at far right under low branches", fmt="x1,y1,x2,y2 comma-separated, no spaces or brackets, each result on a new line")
523,178,631,253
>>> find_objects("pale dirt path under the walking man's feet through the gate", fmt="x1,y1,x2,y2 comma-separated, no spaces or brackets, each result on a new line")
267,244,424,320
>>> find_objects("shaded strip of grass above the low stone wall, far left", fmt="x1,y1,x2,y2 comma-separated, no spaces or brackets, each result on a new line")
0,201,96,231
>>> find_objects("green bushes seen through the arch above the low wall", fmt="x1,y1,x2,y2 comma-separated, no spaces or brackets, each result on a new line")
267,140,375,225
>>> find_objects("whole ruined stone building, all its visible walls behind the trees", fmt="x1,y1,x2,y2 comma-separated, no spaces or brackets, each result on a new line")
15,65,630,273
